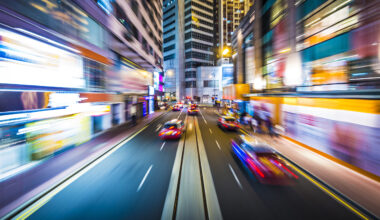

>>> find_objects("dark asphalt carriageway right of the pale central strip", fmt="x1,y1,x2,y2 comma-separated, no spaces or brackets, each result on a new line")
198,108,359,219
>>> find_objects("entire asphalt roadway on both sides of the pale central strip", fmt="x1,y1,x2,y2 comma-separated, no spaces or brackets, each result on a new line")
23,108,359,219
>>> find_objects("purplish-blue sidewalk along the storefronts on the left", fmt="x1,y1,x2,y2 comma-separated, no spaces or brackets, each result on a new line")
0,110,167,218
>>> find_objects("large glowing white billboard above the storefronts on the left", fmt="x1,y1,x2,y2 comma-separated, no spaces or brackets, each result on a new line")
0,29,86,88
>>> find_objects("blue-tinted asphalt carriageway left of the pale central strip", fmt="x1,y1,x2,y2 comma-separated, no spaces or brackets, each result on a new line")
30,109,186,219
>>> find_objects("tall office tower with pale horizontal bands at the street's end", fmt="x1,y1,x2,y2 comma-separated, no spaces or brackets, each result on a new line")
163,0,214,100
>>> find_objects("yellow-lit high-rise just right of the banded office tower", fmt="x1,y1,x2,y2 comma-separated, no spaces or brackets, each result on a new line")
214,0,254,64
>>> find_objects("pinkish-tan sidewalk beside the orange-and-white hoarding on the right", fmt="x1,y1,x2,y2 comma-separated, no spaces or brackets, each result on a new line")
243,130,380,216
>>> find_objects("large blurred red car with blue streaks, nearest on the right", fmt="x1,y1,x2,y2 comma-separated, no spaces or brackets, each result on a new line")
231,135,298,184
